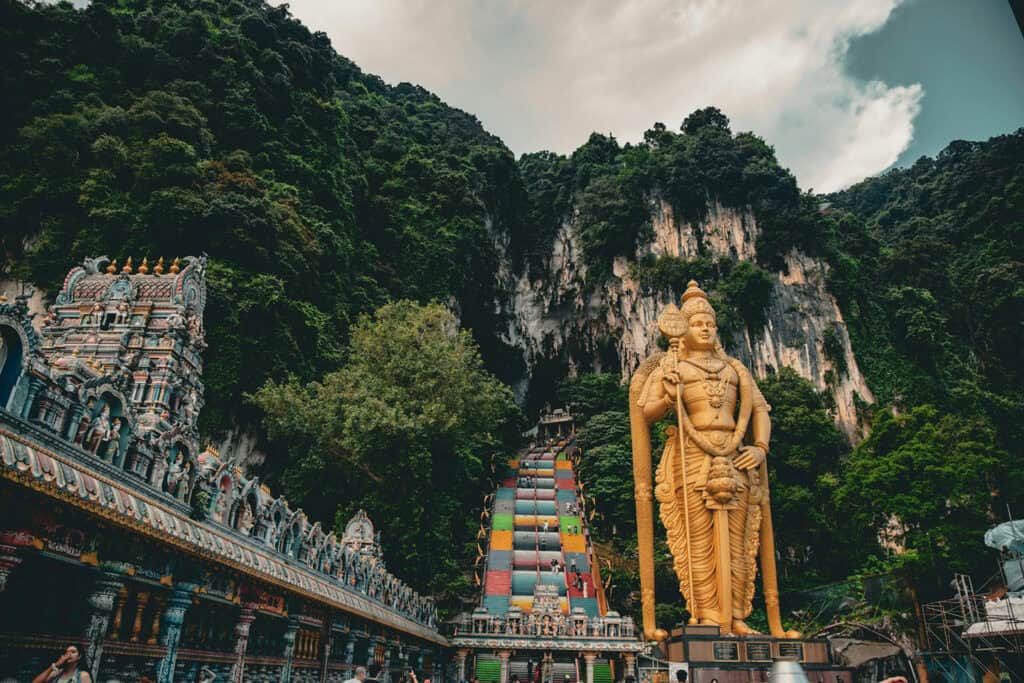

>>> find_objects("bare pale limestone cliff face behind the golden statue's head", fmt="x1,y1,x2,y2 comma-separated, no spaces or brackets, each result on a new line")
499,201,873,440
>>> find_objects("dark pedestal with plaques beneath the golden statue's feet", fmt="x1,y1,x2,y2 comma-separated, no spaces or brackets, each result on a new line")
662,626,853,683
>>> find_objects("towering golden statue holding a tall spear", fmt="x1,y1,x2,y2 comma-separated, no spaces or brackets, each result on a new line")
630,281,800,640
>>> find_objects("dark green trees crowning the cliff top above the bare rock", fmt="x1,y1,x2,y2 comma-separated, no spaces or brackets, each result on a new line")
513,106,806,286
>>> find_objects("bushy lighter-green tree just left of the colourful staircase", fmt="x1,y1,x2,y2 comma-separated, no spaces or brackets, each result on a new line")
253,301,520,593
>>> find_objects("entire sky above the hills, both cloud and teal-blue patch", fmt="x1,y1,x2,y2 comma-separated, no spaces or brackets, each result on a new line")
280,0,1024,191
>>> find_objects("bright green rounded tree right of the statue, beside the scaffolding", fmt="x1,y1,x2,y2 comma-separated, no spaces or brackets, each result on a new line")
836,405,1021,598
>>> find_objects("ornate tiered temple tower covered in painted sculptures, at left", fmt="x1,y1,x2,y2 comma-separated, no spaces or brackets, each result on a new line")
24,257,206,485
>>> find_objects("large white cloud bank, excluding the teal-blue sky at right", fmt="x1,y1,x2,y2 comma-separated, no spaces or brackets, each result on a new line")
278,0,924,191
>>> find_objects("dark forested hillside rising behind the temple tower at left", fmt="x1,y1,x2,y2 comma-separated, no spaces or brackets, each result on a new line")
0,0,522,433
